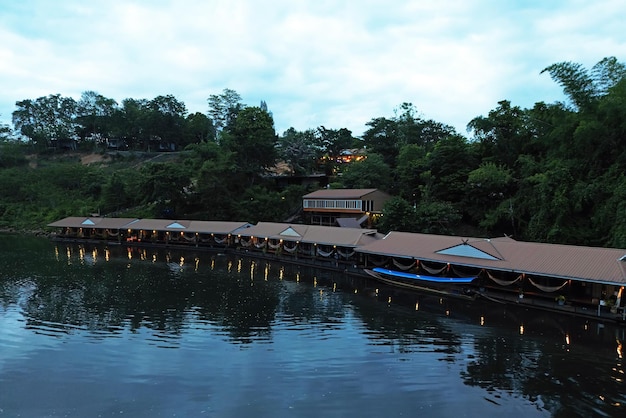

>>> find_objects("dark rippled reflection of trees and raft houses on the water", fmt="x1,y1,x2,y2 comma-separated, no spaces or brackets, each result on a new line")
0,237,626,417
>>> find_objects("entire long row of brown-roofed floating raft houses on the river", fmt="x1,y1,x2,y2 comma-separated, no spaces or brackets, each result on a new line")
48,216,626,322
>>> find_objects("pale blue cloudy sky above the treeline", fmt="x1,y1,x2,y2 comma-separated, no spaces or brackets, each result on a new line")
0,0,626,135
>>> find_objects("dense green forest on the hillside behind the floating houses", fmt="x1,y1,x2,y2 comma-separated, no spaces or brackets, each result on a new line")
0,57,626,248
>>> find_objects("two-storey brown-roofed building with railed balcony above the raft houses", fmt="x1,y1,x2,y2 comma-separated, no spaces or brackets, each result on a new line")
302,189,391,228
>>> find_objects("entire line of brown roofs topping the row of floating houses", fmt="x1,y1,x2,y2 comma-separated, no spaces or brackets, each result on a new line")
48,217,626,284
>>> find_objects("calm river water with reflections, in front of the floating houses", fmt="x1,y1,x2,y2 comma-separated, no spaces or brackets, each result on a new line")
0,235,626,418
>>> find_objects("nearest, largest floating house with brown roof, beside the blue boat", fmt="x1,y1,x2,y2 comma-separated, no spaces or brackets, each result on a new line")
357,232,626,307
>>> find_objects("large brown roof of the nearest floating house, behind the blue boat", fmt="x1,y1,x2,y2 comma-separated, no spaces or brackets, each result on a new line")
357,232,626,284
